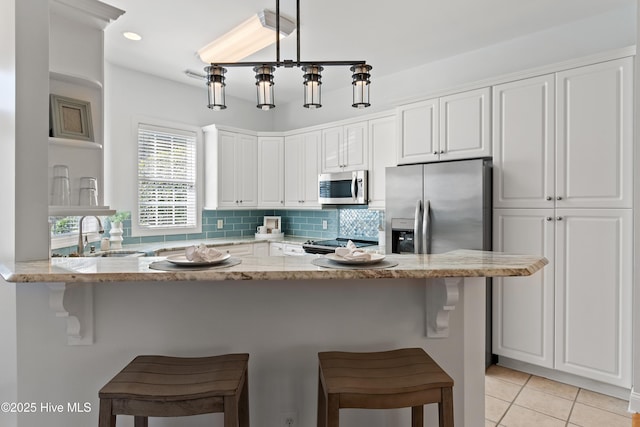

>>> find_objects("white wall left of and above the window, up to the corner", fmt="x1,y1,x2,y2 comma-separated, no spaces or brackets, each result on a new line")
104,63,273,211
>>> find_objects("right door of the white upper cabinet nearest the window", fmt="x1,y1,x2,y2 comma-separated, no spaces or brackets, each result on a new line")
234,134,258,207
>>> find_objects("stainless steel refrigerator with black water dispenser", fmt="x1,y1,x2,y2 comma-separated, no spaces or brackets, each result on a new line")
385,158,492,364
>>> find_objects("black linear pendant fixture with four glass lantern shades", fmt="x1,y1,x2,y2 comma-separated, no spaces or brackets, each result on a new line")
200,0,371,110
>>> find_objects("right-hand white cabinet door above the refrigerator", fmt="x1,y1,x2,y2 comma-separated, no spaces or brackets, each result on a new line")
439,87,491,160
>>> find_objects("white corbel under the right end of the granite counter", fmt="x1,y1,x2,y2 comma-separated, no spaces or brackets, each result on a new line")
425,277,464,338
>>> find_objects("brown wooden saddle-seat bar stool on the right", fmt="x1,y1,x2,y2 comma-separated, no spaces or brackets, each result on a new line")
318,348,453,427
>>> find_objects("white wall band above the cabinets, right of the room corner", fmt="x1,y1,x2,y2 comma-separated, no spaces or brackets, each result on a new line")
275,2,636,130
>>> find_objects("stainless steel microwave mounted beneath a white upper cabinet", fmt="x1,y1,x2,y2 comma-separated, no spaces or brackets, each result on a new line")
318,170,369,205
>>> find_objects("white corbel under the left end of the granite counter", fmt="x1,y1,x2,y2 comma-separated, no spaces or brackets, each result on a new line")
46,283,93,345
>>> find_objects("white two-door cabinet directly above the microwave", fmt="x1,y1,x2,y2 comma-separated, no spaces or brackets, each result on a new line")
320,121,369,173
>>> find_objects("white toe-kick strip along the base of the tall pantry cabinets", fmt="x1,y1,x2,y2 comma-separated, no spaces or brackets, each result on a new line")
497,356,640,402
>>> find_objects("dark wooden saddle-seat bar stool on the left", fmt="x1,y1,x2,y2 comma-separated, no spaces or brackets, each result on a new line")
98,354,249,427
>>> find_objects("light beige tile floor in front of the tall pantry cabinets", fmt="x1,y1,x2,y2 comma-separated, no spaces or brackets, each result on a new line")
485,365,631,427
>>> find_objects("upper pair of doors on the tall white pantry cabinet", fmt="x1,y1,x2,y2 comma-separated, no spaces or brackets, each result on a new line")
493,58,633,208
